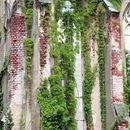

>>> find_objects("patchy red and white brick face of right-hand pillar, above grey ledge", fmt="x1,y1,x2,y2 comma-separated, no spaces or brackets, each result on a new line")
110,16,123,102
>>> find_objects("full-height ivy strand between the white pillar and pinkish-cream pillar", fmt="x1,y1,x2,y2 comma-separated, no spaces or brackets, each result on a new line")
82,0,98,130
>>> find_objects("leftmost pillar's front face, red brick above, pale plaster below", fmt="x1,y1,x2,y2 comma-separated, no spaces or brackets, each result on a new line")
9,13,26,130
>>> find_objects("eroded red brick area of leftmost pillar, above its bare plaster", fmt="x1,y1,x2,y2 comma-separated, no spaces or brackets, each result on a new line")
9,15,25,99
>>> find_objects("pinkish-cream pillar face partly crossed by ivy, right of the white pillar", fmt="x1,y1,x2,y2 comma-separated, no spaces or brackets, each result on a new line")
89,39,102,130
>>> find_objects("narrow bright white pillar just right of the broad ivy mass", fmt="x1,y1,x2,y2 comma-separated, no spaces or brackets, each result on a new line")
75,35,86,130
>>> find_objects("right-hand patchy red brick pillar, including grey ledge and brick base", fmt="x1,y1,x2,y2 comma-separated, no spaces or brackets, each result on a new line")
109,13,128,130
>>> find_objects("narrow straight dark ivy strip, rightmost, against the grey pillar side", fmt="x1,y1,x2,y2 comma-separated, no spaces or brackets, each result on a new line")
98,9,106,130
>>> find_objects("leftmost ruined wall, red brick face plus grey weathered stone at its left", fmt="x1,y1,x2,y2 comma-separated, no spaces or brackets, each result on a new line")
0,0,26,129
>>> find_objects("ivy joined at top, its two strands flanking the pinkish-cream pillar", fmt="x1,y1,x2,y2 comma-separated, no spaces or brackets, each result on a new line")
82,0,106,130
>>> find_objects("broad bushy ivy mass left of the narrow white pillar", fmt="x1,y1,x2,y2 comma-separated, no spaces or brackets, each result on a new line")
38,0,82,130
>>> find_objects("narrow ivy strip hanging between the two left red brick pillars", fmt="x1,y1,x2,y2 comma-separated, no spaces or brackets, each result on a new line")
22,0,34,105
